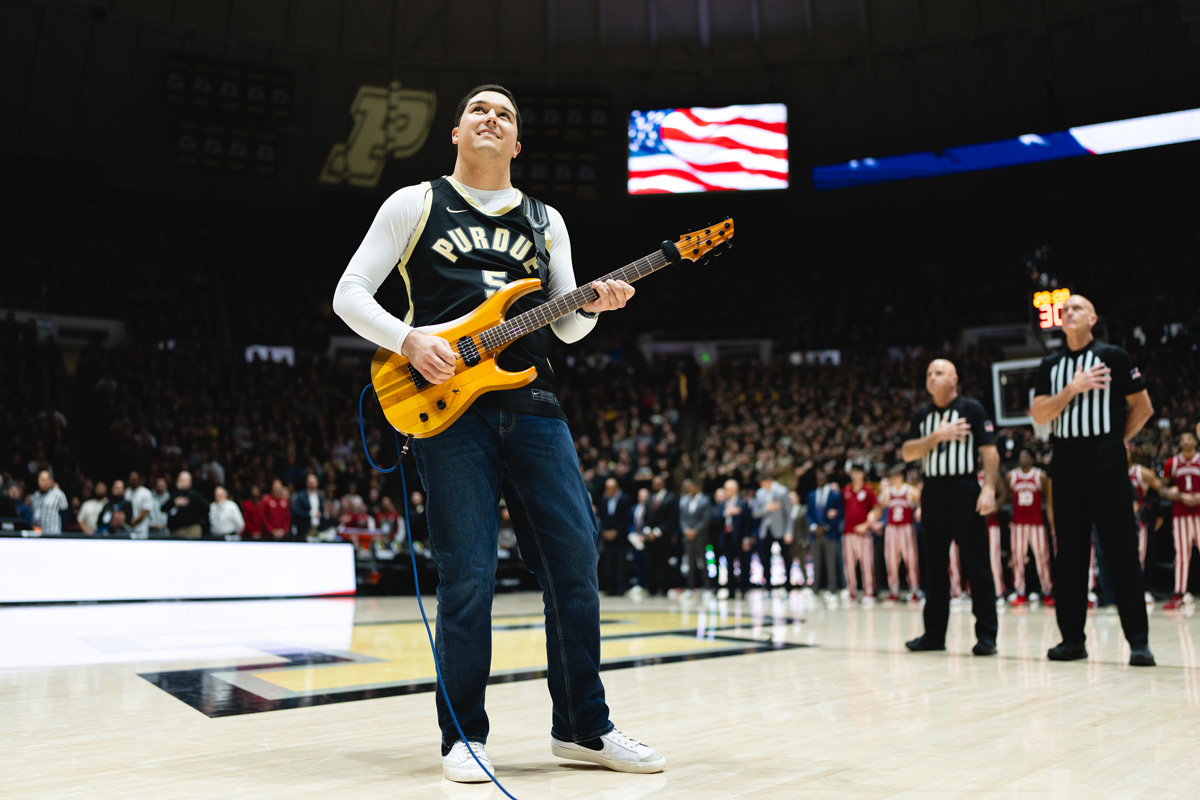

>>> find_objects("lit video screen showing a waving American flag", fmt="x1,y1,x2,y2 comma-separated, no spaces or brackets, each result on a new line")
629,103,787,194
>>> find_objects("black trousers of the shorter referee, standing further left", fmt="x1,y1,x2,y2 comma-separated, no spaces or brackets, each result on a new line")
920,476,998,644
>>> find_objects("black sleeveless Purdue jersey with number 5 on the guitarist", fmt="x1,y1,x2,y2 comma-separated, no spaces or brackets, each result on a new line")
397,178,566,420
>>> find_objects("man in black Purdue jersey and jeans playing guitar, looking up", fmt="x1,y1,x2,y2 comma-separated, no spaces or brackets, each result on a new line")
334,85,666,782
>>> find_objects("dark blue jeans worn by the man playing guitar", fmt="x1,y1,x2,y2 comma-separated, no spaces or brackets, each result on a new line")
413,408,613,745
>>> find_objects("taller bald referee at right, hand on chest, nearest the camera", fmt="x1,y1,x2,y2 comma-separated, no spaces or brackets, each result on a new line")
1033,295,1154,667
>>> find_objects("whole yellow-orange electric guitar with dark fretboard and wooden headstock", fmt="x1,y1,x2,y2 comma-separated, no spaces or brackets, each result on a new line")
371,219,733,439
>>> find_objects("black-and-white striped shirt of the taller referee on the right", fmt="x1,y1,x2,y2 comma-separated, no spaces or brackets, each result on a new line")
1033,341,1146,444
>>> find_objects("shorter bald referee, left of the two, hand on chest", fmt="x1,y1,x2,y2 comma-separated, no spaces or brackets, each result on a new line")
900,359,1000,656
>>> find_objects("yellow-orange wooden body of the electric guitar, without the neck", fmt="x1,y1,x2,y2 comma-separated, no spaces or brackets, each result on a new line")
371,278,541,439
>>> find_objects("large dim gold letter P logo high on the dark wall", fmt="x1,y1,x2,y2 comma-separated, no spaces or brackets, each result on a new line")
318,80,438,188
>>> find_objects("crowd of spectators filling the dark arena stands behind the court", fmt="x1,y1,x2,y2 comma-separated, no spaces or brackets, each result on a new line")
0,183,1200,606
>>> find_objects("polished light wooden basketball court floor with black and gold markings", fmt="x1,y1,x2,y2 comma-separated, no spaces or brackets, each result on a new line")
0,593,1200,800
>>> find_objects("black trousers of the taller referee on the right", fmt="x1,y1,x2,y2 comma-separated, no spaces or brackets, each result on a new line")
1050,441,1150,646
